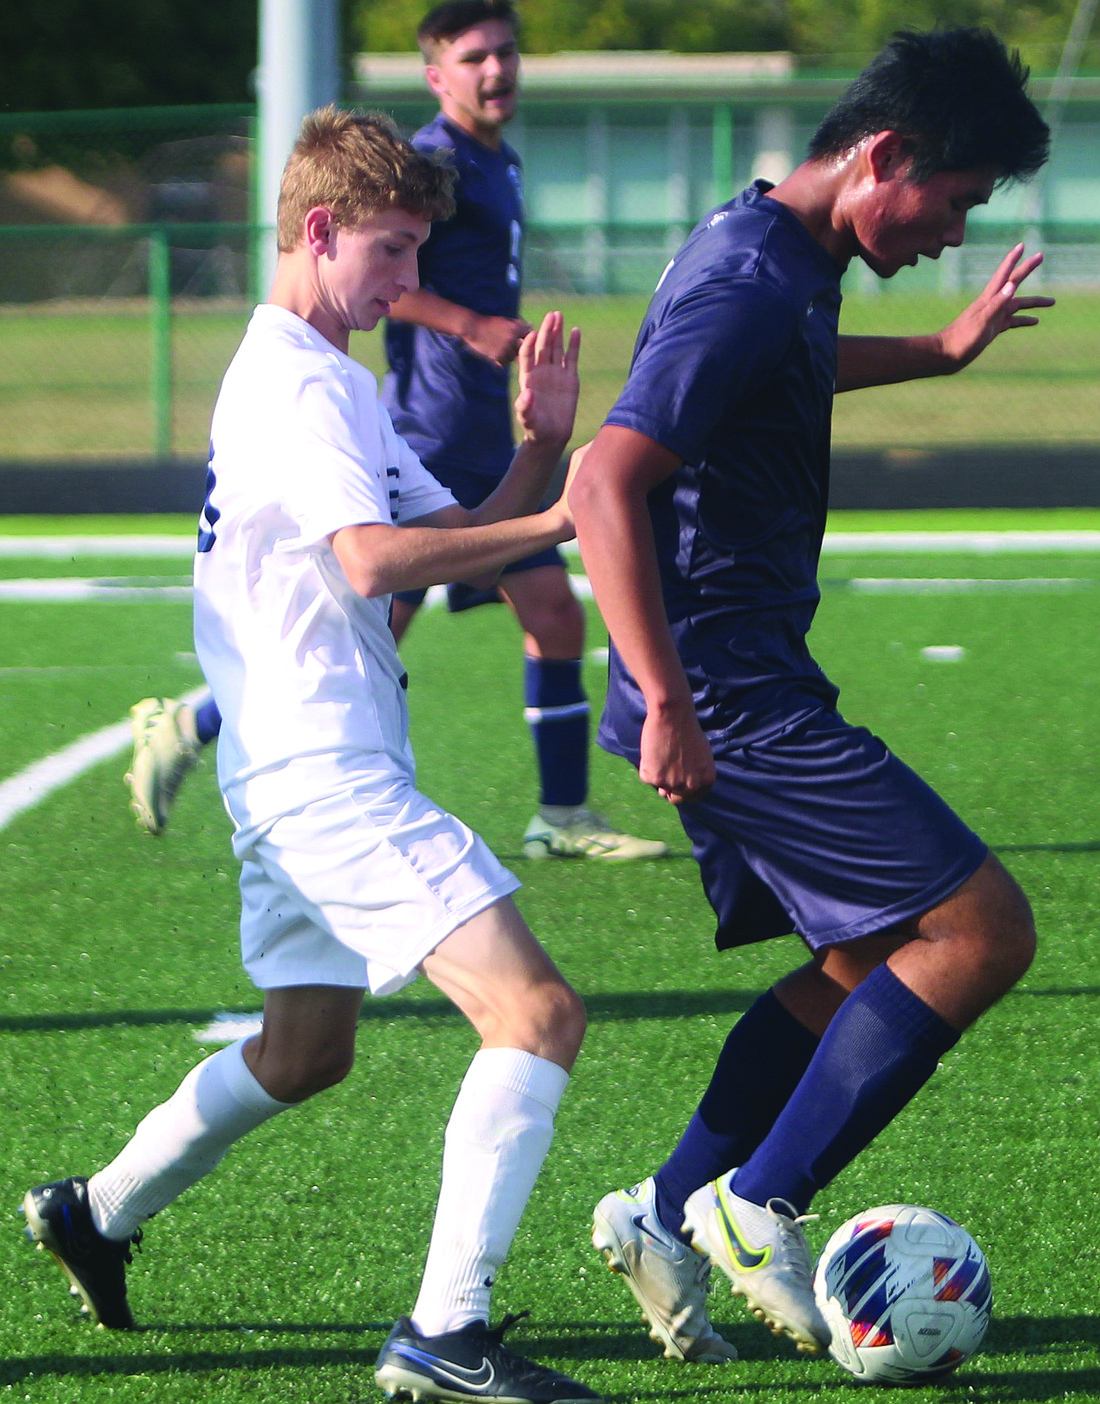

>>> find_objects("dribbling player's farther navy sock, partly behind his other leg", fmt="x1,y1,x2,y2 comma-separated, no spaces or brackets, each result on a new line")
653,990,818,1241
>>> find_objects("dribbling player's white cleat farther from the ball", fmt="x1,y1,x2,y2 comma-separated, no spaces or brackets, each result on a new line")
591,1178,738,1365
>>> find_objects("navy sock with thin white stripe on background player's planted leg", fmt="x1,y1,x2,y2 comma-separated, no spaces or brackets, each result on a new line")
524,654,589,804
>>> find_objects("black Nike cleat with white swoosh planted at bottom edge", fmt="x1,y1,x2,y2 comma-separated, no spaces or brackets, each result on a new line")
374,1311,600,1404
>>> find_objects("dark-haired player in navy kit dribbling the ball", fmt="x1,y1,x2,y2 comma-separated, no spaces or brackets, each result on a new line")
570,28,1051,1359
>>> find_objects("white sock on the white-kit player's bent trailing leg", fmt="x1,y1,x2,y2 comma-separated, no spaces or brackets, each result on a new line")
89,1039,294,1240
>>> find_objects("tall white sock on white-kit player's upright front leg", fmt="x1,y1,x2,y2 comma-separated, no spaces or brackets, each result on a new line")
412,1049,569,1335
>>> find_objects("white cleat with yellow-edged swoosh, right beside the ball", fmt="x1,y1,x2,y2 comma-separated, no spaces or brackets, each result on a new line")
684,1171,830,1355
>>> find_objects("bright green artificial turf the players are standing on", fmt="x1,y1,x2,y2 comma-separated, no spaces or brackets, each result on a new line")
0,512,1100,1404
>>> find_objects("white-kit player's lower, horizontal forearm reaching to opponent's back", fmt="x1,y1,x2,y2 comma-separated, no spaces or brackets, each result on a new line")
333,508,572,598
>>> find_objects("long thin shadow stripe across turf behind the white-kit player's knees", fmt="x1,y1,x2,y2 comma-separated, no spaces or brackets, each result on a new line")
0,990,760,1033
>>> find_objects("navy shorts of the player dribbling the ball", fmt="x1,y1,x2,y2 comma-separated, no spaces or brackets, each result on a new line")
680,706,988,951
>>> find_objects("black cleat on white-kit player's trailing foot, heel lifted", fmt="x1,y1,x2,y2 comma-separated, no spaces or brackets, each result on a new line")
22,1175,142,1331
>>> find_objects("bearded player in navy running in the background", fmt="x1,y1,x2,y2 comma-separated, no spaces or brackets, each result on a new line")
382,0,667,859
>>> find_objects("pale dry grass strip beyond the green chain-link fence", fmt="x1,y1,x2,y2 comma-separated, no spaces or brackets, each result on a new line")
0,282,1100,461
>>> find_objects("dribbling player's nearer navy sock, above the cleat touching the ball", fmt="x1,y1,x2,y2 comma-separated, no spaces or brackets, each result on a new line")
732,965,958,1213
